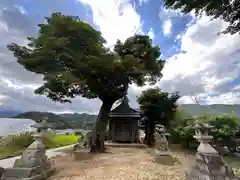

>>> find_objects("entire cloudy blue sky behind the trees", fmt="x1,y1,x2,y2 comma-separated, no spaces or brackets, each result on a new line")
0,0,240,113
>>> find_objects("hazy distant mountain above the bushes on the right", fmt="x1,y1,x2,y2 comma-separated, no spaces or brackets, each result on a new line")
180,104,240,117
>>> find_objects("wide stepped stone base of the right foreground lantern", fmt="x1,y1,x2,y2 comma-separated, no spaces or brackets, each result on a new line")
186,152,240,180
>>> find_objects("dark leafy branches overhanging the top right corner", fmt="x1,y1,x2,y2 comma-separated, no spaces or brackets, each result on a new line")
164,0,240,34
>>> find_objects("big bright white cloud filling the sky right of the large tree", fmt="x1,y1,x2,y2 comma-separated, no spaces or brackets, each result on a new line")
160,14,240,104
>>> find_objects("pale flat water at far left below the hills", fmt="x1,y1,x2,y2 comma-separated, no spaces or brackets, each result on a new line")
0,118,36,136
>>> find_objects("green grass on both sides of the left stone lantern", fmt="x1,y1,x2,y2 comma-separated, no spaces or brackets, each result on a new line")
0,132,80,159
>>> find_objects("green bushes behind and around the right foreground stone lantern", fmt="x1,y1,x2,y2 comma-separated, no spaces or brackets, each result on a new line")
170,109,240,148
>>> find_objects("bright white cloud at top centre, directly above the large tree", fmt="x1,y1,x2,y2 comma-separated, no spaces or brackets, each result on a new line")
79,0,142,47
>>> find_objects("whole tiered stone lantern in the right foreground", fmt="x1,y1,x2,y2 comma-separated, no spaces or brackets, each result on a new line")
186,121,239,180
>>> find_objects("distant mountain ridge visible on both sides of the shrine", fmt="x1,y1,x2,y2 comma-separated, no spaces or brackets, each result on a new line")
10,104,240,129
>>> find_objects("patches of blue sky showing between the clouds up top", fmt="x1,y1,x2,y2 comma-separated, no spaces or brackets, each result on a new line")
3,0,192,57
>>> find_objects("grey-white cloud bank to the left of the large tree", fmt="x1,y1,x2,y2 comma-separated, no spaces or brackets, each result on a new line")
0,2,100,113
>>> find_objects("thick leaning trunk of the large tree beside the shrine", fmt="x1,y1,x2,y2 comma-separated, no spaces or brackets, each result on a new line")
90,102,114,152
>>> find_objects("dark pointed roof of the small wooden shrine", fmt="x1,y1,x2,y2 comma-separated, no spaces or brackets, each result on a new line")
109,99,140,117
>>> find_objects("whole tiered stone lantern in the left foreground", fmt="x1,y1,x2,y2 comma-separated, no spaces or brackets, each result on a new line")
2,121,54,180
